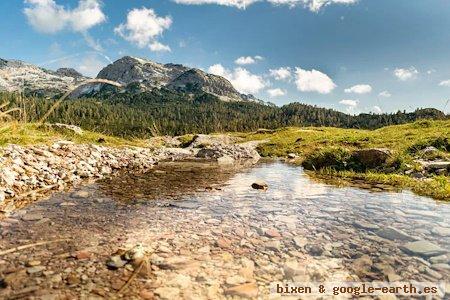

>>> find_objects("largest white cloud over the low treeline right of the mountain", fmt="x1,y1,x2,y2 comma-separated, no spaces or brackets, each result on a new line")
295,68,336,94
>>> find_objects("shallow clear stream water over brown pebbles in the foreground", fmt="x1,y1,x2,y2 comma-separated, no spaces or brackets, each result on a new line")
0,162,450,299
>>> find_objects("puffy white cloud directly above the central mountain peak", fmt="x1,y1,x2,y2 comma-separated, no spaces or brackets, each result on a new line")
114,7,172,51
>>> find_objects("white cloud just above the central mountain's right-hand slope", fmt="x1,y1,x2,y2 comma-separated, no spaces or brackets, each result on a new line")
208,64,266,94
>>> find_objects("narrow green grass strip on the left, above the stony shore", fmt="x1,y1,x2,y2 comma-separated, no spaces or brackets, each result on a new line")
0,122,149,147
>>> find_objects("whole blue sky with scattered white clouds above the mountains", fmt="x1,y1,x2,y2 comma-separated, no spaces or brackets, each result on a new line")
0,0,450,114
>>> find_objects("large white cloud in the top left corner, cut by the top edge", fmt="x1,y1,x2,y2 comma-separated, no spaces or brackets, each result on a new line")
24,0,106,34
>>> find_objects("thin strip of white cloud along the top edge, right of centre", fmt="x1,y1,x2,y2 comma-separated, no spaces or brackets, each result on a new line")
174,0,358,12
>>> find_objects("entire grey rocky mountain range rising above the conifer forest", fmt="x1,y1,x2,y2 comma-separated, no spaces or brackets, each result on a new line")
0,56,266,104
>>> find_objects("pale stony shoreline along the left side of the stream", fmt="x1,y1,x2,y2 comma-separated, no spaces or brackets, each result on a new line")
0,136,259,214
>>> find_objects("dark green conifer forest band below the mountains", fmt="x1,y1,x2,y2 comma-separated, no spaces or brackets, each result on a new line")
0,90,447,138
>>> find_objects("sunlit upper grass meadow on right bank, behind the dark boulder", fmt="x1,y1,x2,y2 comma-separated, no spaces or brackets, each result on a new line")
235,120,450,157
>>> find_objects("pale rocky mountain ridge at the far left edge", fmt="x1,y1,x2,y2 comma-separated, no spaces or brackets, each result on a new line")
0,58,86,97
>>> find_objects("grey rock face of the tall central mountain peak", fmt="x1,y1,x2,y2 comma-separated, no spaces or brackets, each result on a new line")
97,56,252,101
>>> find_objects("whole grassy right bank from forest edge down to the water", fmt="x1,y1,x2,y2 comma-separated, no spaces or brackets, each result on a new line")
235,120,450,201
